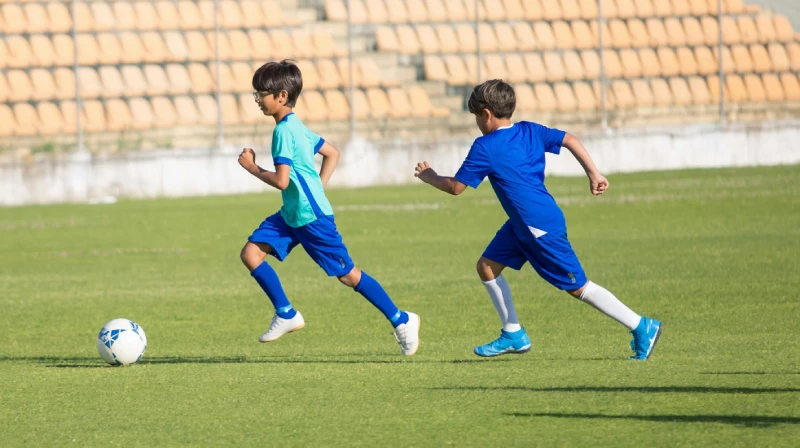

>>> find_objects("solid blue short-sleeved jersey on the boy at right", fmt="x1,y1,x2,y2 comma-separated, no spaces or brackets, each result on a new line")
455,121,566,239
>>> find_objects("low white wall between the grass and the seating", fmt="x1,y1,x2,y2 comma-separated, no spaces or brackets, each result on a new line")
0,121,800,205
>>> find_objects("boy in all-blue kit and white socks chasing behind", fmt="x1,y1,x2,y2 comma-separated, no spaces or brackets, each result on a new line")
415,80,662,359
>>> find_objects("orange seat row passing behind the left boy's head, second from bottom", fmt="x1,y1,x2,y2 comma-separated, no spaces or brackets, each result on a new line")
0,58,400,102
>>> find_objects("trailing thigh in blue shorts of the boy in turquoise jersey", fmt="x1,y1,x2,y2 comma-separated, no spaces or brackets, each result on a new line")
295,216,355,277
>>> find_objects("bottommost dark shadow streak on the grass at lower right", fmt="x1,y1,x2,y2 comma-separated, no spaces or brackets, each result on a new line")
504,412,800,428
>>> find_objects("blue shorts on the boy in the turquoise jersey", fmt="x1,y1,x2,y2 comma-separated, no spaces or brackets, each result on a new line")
247,212,355,277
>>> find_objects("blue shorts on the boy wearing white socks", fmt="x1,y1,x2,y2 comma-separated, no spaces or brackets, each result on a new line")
483,221,586,291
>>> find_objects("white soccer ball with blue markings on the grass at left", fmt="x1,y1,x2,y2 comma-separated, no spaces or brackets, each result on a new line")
97,319,147,366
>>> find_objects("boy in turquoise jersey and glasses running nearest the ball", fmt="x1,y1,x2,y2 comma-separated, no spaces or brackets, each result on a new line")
239,61,420,355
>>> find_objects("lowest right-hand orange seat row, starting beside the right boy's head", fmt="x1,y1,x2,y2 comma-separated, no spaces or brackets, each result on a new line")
514,73,800,112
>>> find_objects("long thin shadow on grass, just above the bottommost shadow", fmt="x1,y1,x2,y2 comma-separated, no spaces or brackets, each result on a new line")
429,386,800,394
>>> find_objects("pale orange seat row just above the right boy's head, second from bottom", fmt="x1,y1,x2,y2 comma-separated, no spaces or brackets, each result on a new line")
423,43,800,85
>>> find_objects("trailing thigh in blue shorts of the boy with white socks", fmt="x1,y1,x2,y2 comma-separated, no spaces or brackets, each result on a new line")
523,229,586,291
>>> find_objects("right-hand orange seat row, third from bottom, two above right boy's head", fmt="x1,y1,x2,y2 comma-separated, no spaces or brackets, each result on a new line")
376,14,797,54
